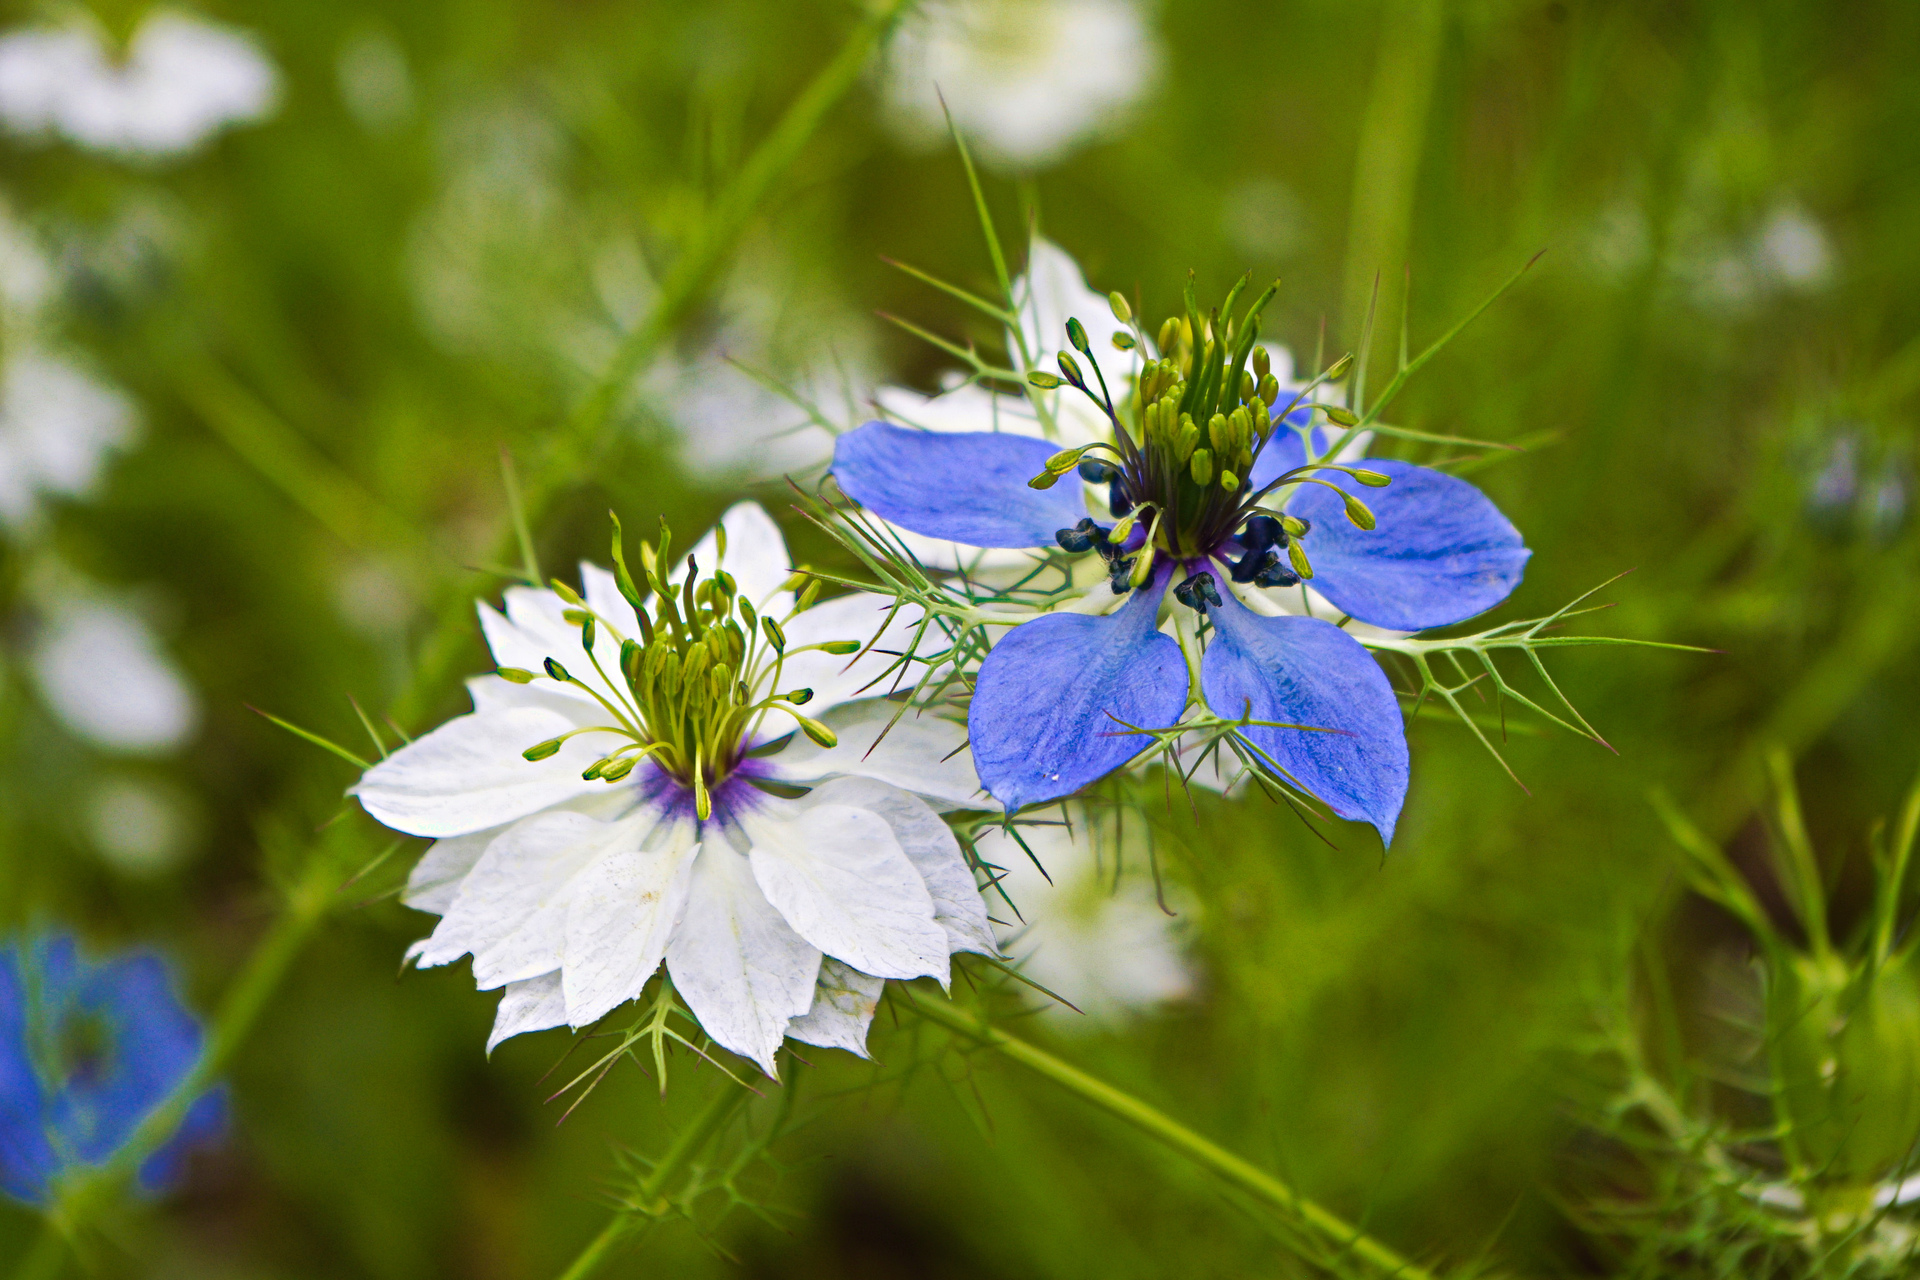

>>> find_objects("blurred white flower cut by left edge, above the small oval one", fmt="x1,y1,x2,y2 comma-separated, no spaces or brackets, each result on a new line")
0,347,136,528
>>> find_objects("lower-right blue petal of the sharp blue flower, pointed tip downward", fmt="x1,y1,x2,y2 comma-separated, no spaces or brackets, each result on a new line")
1200,597,1407,844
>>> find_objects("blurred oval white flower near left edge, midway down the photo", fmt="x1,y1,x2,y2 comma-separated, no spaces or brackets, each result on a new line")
31,591,200,752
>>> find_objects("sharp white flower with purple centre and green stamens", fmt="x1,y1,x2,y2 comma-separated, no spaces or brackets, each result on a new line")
353,503,995,1073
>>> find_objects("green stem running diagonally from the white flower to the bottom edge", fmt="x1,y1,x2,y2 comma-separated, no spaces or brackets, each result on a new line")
893,984,1432,1280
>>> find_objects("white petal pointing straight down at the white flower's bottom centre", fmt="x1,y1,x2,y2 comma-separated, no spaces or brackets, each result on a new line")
666,852,820,1077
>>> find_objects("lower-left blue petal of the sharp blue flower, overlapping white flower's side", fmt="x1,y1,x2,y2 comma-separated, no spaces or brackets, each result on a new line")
968,572,1188,812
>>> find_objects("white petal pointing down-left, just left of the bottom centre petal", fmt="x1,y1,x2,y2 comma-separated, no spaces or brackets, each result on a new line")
563,821,699,1027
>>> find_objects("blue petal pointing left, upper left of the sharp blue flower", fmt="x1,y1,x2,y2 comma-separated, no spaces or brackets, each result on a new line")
833,422,1087,547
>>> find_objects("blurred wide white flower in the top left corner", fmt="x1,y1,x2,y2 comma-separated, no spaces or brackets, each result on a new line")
0,10,278,157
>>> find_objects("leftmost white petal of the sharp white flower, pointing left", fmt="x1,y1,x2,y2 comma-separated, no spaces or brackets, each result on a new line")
348,706,612,837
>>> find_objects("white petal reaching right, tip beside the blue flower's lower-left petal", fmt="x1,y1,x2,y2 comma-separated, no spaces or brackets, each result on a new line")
758,699,998,810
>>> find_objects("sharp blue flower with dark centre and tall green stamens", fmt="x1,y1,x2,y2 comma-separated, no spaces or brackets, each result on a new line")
833,290,1530,842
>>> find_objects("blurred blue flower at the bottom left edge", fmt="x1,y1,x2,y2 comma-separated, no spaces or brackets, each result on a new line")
0,936,227,1205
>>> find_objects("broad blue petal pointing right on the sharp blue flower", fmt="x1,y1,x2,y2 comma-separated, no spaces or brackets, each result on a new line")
1286,459,1532,631
